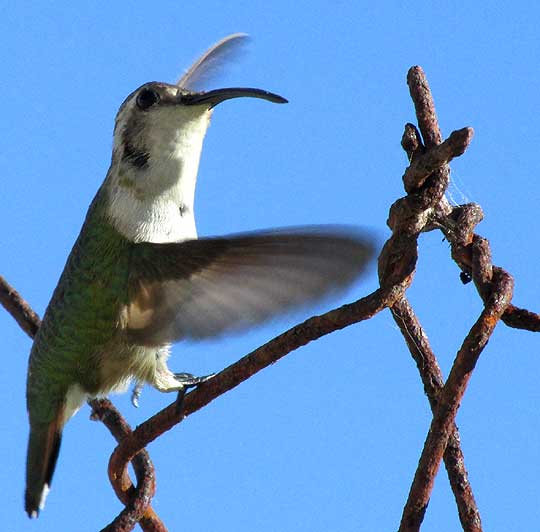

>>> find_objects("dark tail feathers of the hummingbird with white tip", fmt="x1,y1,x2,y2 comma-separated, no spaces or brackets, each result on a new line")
25,416,62,518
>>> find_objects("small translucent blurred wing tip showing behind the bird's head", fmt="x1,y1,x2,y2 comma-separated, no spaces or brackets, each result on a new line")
176,33,249,92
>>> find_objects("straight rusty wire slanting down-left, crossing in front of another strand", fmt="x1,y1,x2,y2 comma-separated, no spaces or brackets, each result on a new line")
399,268,513,532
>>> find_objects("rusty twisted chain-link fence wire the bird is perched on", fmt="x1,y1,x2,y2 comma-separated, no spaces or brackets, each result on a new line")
0,67,540,532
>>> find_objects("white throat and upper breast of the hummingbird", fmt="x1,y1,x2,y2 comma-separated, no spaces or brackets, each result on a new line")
107,113,210,243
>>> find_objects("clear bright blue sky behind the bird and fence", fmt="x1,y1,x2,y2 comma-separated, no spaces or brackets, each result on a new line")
0,0,540,532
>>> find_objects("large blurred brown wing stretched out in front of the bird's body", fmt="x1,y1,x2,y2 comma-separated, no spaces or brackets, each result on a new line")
124,226,375,345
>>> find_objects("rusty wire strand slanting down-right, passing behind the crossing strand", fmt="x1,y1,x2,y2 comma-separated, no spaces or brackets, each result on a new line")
391,297,482,532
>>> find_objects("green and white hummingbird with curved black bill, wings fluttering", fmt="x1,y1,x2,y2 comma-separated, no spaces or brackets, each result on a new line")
25,34,374,517
